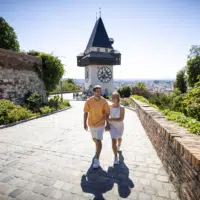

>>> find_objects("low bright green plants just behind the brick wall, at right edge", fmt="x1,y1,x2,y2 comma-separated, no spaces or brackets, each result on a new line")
163,110,200,135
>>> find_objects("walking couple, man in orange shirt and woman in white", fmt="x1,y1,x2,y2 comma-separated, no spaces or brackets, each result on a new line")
84,85,125,168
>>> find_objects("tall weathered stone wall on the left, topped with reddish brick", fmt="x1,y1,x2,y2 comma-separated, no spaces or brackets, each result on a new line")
0,49,46,104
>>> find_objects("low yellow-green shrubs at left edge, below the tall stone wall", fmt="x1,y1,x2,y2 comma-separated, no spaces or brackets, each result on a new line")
0,99,36,125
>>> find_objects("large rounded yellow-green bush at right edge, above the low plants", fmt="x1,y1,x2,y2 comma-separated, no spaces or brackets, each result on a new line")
183,76,200,121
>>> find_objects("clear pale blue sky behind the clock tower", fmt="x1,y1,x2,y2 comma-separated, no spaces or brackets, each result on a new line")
0,0,200,79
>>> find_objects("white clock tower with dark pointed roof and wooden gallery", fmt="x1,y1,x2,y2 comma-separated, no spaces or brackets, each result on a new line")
77,17,121,95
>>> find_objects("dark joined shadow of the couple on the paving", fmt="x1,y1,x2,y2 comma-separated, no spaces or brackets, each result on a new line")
81,152,134,200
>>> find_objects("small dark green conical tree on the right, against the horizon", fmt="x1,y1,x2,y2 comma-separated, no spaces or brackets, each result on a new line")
174,69,187,93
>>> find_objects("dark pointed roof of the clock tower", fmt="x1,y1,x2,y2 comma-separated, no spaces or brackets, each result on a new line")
86,17,113,50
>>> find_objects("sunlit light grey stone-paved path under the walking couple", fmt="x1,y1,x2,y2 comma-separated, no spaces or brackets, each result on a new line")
0,101,178,200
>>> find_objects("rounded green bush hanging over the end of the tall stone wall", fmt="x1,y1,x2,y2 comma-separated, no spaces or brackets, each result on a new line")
27,50,64,93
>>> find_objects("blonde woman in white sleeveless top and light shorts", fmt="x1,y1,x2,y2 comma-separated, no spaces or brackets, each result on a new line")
109,92,125,165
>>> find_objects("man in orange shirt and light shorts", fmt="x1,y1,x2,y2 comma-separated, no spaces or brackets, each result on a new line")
84,85,109,168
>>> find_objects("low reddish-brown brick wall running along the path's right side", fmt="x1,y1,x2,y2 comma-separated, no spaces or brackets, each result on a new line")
131,100,200,200
